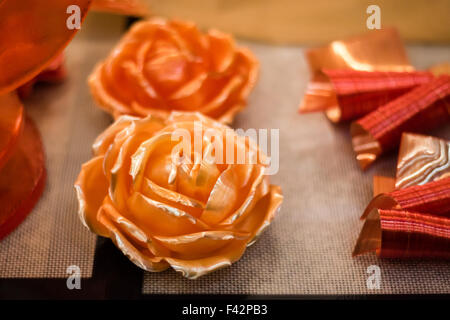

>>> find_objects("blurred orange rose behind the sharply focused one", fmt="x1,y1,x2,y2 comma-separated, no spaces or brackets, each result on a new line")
89,18,259,123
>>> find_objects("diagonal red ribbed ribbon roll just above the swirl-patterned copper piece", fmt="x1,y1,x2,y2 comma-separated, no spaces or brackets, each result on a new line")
351,75,450,169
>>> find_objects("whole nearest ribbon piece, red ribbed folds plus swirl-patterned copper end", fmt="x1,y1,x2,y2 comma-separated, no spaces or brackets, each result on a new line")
353,133,450,259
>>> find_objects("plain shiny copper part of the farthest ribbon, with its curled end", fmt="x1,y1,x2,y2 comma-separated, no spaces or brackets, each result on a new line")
299,28,414,113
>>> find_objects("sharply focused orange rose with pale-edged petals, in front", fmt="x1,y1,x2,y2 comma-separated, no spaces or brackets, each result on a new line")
75,112,283,278
